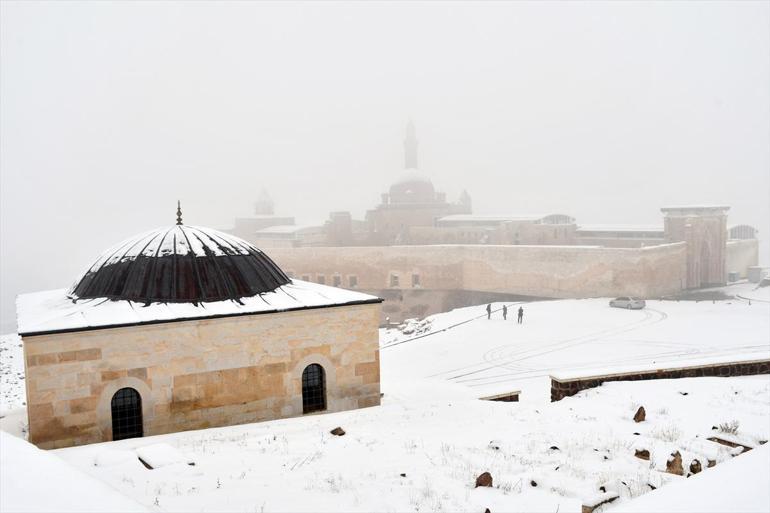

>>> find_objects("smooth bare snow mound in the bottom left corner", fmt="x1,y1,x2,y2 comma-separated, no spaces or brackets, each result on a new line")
0,431,148,513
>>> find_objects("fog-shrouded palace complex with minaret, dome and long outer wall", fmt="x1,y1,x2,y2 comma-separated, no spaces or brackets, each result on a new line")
219,122,759,322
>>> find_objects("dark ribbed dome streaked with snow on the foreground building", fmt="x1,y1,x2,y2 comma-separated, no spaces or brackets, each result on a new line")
70,225,290,303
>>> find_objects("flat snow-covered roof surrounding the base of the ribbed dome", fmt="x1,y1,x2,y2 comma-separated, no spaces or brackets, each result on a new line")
16,280,382,336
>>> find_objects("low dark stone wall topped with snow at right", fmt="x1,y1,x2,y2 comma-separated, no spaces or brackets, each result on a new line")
551,360,770,402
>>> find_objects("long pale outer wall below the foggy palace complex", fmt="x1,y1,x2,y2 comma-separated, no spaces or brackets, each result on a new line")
270,243,686,298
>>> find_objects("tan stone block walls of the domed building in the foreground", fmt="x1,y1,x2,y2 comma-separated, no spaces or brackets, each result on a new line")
23,304,380,448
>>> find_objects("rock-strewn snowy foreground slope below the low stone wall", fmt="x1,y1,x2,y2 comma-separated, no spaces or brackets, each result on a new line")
48,376,770,513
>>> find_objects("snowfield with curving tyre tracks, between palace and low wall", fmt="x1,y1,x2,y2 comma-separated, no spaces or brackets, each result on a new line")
380,299,770,402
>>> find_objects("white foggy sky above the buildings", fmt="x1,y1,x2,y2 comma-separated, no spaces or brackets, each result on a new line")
0,2,770,333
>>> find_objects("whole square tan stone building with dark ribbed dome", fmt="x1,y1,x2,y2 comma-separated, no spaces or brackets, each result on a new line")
17,217,382,448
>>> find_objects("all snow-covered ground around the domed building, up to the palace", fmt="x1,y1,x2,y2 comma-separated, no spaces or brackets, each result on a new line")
0,284,770,512
